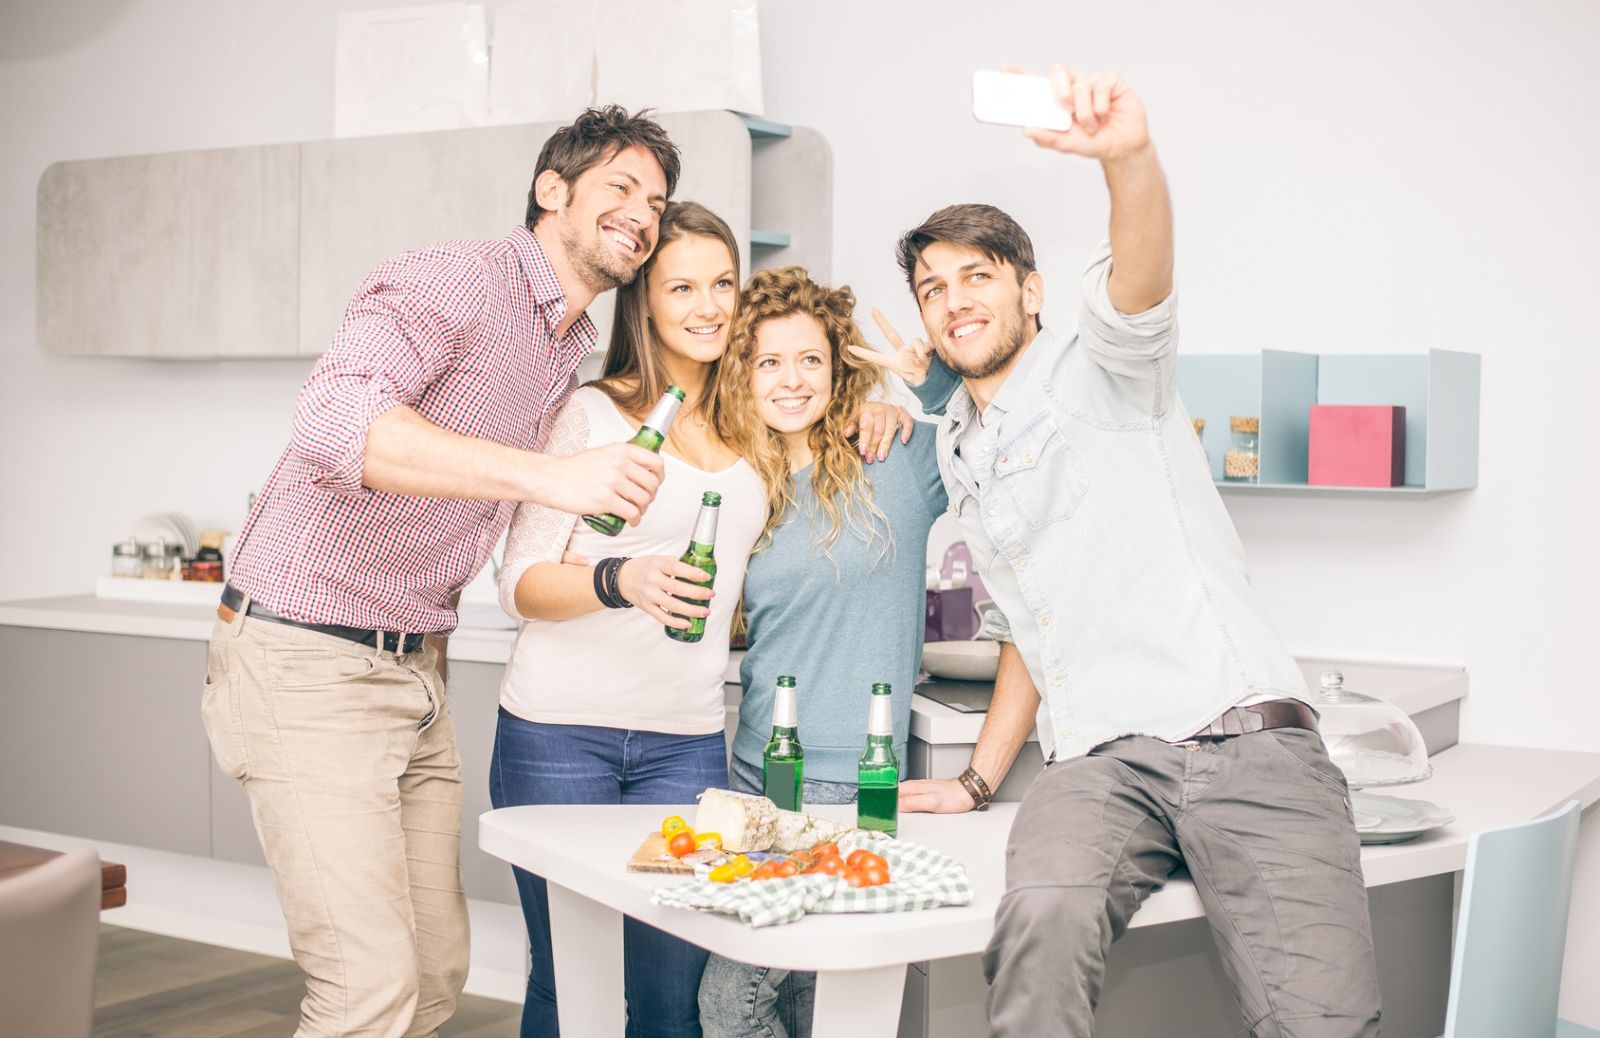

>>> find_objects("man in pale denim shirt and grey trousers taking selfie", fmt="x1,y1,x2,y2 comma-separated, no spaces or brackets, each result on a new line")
856,67,1379,1038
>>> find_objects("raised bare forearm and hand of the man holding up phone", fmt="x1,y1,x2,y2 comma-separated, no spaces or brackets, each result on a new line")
1022,66,1173,313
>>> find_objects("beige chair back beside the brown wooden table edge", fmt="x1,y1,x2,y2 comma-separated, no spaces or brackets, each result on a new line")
0,849,101,1038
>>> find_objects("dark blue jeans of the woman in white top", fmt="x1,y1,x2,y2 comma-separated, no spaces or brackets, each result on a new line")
490,710,728,1038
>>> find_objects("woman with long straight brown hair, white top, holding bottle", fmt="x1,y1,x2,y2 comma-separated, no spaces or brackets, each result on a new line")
490,202,766,1038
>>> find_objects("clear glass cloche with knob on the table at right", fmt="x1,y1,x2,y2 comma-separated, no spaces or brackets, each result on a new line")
1315,670,1434,788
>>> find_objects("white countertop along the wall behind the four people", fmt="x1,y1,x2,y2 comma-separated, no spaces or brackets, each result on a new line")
0,589,1467,735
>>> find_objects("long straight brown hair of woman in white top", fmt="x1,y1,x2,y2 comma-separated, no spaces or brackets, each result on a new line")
594,202,749,422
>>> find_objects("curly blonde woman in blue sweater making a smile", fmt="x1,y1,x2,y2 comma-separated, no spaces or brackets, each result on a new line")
701,267,946,1038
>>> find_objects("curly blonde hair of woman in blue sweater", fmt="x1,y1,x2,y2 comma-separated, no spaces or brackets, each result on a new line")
717,267,893,558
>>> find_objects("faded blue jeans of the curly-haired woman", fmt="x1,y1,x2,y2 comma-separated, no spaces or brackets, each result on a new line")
701,757,856,1038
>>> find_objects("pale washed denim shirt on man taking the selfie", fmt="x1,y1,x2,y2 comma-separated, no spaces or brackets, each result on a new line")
917,243,1309,760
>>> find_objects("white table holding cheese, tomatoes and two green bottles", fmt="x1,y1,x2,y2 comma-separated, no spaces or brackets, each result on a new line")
478,745,1600,1038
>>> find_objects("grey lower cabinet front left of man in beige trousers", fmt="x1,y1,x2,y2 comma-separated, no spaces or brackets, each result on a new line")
0,627,213,854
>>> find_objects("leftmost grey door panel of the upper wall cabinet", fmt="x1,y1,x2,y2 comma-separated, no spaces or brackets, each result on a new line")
38,144,299,357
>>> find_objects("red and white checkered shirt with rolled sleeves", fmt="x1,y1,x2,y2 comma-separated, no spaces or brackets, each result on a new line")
229,227,595,633
